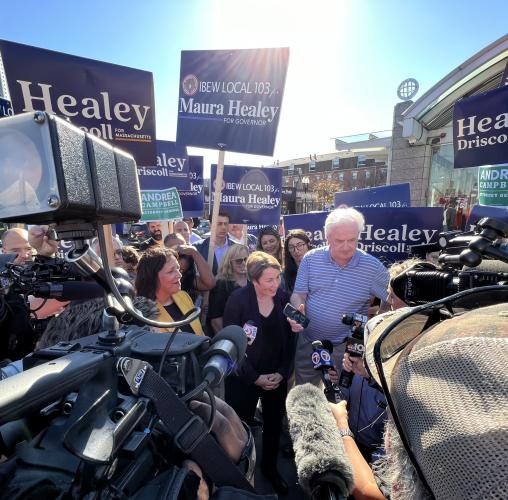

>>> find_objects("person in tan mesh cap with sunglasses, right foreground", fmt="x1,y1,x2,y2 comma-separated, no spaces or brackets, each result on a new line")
331,292,508,500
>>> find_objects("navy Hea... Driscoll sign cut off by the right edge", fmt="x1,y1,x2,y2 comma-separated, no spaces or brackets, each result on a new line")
453,85,508,168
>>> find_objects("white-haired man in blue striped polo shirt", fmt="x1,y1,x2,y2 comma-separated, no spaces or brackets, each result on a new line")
289,208,389,385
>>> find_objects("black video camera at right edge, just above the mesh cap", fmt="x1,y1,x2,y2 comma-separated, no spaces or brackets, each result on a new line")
390,217,508,305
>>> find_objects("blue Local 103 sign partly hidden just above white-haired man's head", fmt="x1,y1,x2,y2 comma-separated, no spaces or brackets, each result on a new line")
335,183,411,208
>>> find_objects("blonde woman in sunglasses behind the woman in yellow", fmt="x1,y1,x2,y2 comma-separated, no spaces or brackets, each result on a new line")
208,243,249,334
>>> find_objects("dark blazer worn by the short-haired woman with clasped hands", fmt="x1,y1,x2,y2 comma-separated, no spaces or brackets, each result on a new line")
223,283,295,384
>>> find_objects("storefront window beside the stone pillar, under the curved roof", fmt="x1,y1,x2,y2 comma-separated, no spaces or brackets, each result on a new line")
427,144,478,225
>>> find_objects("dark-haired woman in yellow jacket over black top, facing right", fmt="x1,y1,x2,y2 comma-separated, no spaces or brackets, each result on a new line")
135,247,203,335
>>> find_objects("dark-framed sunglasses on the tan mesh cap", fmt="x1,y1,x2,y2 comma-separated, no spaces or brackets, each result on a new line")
373,285,508,491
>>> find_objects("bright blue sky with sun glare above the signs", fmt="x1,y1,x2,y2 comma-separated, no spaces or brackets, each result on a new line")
0,0,508,174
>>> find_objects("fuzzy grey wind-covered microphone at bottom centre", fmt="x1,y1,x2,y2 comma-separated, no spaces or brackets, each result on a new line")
286,384,354,500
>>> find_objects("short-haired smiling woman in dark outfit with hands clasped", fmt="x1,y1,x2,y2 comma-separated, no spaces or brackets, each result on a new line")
223,252,293,494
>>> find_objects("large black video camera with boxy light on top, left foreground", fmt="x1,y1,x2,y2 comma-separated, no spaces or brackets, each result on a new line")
0,112,253,500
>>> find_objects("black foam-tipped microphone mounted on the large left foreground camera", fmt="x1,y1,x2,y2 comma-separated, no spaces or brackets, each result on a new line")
202,325,247,387
